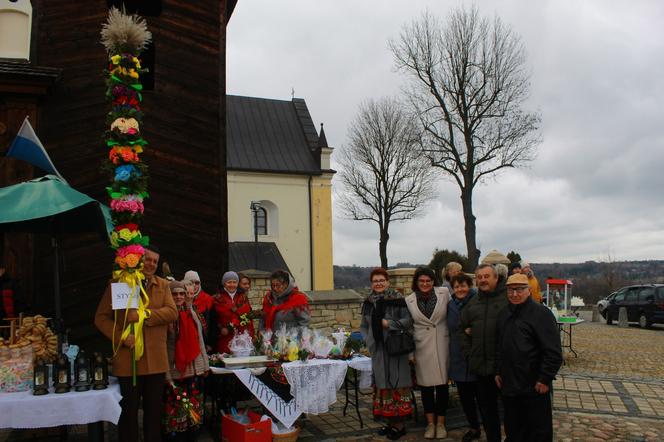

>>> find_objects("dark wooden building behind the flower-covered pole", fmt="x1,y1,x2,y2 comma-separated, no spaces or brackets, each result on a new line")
0,0,236,341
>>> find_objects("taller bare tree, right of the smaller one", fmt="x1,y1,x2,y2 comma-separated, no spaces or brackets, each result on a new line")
390,7,540,266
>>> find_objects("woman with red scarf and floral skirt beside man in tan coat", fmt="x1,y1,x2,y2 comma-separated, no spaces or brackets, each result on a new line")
161,281,210,441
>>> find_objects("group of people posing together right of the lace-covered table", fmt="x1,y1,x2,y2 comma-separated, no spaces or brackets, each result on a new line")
361,262,562,442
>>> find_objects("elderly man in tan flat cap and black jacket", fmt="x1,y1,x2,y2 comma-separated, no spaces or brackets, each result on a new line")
496,274,563,442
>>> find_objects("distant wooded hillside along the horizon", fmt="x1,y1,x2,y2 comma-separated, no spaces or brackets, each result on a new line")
334,260,664,304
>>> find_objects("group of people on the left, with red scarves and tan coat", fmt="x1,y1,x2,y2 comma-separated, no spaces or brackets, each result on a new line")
95,245,310,442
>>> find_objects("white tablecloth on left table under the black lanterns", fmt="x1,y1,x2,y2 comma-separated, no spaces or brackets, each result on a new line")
0,383,122,428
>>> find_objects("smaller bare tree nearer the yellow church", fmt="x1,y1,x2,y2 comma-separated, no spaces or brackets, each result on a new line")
337,98,434,268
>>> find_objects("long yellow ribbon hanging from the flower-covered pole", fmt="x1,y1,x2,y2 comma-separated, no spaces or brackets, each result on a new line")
112,270,150,361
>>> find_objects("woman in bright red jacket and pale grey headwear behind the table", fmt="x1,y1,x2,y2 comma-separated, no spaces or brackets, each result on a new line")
214,272,254,353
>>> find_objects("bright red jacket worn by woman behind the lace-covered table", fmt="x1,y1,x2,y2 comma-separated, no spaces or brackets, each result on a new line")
214,289,254,353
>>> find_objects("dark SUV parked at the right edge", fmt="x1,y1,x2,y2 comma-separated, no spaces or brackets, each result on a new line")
603,284,664,328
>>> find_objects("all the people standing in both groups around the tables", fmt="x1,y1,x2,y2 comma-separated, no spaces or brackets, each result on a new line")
95,246,562,442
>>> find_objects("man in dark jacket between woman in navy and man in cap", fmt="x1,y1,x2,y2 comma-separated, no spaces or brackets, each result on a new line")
459,264,508,442
